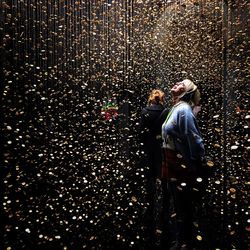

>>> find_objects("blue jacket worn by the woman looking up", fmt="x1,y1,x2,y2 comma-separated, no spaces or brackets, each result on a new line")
162,101,205,168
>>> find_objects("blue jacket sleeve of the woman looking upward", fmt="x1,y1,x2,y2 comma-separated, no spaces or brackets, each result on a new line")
178,107,205,160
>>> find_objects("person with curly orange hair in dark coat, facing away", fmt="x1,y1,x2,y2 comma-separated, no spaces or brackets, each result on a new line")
140,89,168,249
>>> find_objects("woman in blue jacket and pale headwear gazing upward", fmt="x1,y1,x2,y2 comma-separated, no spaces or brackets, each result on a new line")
162,79,205,249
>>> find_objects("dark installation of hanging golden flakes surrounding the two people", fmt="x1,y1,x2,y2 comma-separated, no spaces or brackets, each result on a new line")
0,0,250,250
